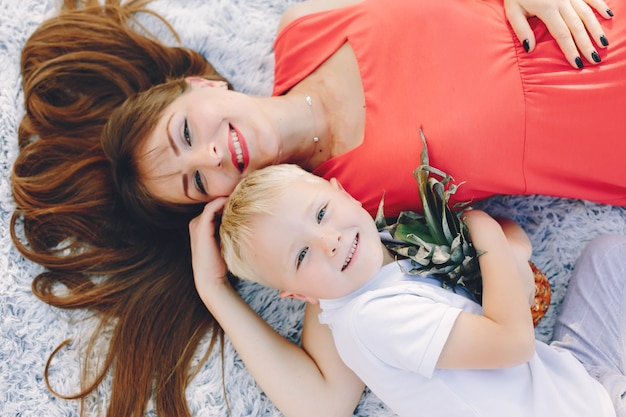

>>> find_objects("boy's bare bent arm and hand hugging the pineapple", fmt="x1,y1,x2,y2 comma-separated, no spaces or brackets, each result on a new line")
437,210,535,369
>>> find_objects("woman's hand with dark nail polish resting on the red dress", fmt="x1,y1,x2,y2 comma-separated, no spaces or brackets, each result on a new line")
504,0,613,68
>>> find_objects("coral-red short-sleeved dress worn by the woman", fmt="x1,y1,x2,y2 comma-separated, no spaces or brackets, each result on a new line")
274,0,626,216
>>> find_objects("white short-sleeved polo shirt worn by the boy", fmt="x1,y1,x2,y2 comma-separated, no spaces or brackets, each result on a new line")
320,263,615,417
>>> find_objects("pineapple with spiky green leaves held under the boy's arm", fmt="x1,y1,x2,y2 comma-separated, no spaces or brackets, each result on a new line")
375,129,550,325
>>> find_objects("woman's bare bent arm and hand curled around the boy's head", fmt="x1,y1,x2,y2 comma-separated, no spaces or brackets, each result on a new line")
189,199,364,417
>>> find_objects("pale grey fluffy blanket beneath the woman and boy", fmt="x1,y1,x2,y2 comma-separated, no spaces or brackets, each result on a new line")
0,0,626,417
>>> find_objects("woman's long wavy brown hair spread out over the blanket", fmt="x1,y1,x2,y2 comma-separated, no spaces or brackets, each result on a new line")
11,0,229,417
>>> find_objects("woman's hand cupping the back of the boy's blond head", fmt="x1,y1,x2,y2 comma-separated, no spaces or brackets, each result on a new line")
189,197,228,302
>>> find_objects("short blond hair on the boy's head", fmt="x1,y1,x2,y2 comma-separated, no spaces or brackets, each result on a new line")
220,164,325,283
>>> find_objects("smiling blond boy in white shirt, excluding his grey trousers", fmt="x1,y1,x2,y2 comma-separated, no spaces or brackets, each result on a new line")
214,165,615,417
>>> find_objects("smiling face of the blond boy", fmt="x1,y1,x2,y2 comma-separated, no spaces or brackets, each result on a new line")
246,178,383,302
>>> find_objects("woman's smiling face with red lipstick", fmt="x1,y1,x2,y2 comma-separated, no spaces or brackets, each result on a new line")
138,78,276,204
